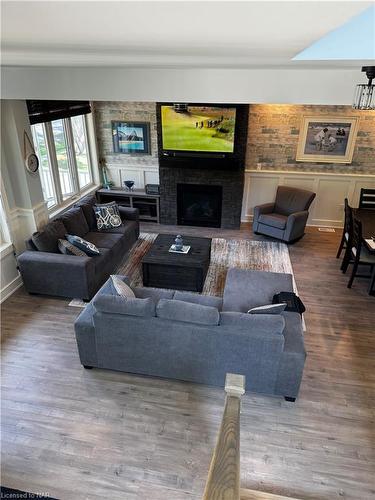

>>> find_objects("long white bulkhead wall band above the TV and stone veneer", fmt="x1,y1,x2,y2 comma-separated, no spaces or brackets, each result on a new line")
2,66,363,104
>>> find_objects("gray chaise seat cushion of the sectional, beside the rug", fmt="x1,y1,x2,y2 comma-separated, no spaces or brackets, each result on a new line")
223,268,293,313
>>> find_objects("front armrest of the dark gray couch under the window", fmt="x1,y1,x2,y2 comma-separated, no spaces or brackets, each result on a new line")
17,251,95,300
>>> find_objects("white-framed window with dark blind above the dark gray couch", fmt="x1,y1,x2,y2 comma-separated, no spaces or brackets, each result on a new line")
31,115,93,210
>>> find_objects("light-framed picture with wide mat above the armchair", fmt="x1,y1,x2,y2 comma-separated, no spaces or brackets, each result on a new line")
296,116,358,163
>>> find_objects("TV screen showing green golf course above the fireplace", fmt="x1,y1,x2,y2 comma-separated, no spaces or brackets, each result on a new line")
161,104,236,153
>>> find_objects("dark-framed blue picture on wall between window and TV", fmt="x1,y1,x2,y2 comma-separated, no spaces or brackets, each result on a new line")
112,122,151,155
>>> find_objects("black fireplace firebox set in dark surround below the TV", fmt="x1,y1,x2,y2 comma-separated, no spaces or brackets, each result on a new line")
177,184,223,227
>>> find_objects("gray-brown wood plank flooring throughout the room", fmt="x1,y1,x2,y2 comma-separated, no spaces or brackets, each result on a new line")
1,224,375,500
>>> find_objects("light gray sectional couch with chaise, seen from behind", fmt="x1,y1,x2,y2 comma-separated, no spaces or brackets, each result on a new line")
75,269,306,400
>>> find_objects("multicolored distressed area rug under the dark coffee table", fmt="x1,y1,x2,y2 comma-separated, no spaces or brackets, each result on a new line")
116,233,293,296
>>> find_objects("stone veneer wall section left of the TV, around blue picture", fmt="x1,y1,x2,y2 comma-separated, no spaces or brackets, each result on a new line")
94,101,159,177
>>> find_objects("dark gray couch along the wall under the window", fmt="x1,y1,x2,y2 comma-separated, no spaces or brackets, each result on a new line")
18,195,139,300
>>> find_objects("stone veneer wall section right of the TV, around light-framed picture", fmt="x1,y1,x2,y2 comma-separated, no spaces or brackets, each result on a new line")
246,104,375,174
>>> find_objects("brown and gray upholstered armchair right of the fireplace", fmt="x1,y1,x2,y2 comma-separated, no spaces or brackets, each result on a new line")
253,186,315,243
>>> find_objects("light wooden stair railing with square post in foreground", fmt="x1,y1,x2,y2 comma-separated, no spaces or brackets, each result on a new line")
203,373,245,500
